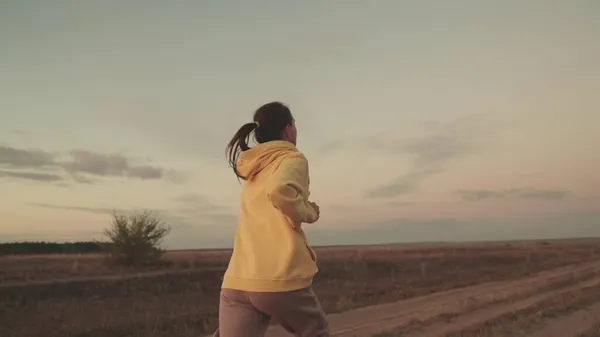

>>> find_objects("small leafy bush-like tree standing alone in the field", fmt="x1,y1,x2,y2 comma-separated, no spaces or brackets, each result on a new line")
104,210,171,266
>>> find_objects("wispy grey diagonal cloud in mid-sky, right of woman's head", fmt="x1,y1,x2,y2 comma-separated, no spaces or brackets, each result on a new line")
366,115,497,198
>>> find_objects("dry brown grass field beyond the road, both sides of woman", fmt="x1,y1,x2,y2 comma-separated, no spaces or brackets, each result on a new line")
0,241,600,337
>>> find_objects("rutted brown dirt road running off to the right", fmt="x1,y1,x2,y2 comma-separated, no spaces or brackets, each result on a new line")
267,261,600,337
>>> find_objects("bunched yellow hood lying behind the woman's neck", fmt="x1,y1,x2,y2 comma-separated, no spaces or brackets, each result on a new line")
236,140,302,180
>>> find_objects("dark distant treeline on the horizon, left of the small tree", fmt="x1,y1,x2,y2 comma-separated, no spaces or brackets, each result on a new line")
0,241,110,255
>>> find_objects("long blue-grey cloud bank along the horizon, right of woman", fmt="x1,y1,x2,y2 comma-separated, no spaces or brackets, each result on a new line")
306,211,600,245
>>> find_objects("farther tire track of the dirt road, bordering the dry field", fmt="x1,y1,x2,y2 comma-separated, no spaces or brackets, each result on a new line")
267,261,600,337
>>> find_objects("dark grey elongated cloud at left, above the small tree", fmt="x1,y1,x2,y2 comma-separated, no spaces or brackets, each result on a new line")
0,146,179,184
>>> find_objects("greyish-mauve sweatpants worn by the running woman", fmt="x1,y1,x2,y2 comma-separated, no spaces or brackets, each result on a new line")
213,288,329,337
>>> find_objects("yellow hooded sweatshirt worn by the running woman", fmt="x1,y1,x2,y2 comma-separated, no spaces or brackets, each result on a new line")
222,141,319,292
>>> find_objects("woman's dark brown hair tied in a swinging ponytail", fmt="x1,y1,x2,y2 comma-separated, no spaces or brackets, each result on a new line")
226,102,294,180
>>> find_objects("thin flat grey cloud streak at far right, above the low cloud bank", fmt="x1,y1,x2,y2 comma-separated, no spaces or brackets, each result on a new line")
456,188,571,202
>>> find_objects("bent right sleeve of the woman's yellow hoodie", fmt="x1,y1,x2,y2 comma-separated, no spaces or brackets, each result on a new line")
267,156,319,226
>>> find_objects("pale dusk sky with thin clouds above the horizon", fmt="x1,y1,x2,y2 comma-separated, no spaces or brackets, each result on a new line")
0,0,600,248
